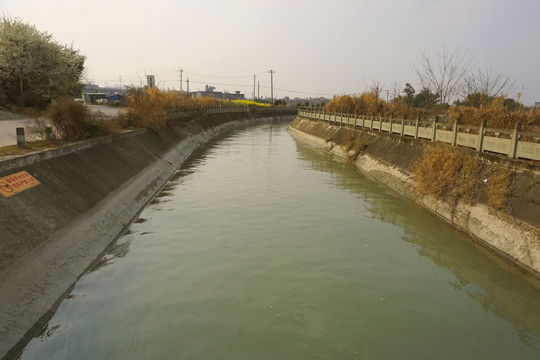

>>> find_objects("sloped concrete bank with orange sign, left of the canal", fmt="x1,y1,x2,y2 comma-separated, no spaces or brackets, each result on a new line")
0,113,294,359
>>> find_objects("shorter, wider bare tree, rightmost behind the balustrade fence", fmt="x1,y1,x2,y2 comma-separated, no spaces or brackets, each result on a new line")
460,69,516,98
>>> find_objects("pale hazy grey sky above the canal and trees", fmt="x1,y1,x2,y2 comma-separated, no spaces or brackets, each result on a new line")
4,0,540,105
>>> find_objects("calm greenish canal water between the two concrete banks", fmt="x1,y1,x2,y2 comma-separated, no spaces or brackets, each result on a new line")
21,123,540,360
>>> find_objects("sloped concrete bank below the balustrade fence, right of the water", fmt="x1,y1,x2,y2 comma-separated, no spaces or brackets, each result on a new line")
288,117,540,279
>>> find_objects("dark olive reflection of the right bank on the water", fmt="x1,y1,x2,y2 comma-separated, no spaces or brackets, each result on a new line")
296,136,540,349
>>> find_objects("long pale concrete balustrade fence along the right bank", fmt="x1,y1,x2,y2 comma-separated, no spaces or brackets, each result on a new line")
298,108,540,161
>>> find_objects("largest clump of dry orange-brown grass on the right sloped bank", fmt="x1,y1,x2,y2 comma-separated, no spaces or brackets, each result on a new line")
414,143,480,204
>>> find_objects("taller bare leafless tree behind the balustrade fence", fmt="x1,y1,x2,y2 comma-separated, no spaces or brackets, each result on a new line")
414,45,472,103
